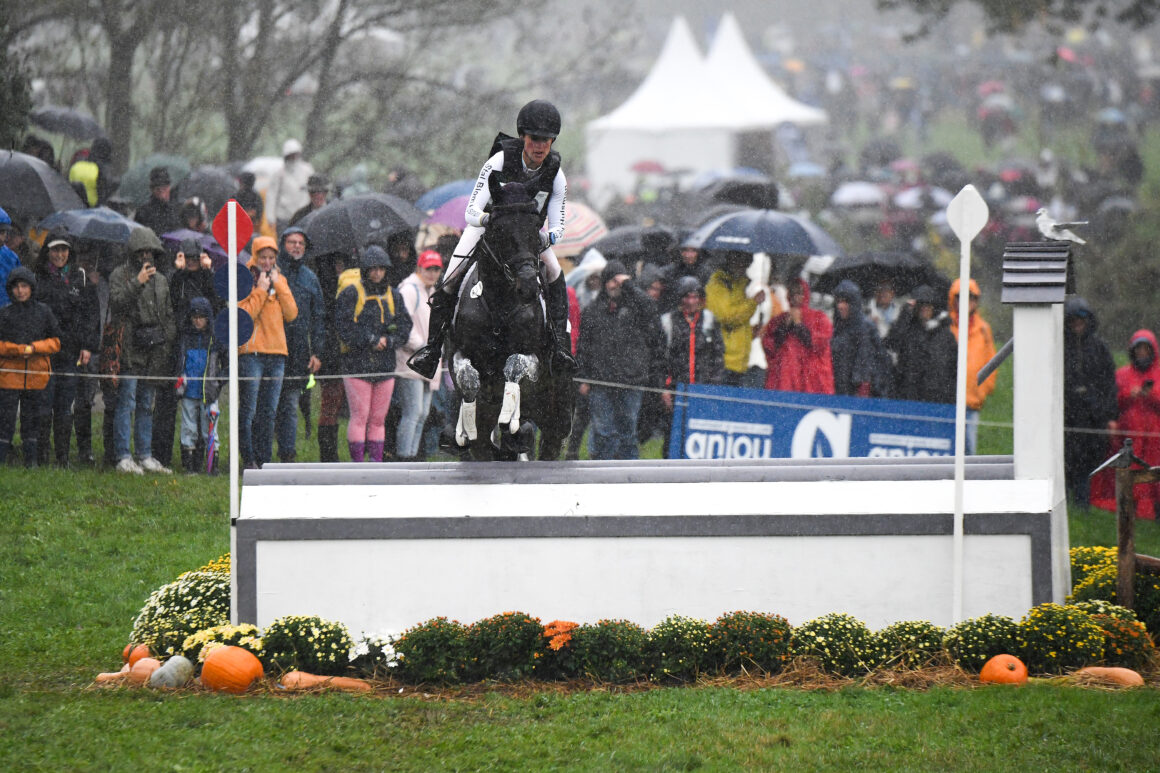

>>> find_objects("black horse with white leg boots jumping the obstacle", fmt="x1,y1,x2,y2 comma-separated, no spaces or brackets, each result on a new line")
450,176,572,460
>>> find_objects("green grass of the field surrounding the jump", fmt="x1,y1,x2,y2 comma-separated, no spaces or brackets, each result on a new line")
0,318,1160,771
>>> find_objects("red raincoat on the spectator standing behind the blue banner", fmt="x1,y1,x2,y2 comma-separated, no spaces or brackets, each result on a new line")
761,280,834,395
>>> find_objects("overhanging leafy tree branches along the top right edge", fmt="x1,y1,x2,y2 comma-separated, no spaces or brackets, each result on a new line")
877,0,1160,35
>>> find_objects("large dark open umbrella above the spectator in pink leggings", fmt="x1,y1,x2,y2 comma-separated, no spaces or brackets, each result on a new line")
298,193,423,257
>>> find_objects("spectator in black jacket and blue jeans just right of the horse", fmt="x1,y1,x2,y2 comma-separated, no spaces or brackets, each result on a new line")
577,260,665,460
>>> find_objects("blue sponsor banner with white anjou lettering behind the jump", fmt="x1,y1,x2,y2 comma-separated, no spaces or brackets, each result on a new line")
669,384,955,460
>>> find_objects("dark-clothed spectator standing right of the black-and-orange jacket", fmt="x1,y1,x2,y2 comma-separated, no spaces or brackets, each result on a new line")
32,236,101,467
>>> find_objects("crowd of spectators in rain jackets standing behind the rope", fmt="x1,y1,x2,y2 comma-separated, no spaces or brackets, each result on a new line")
0,139,1160,524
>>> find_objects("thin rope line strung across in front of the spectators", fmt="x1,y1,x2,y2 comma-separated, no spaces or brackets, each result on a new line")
0,368,1146,438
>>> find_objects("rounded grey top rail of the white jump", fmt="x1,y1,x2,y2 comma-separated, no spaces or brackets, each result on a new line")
244,456,1015,486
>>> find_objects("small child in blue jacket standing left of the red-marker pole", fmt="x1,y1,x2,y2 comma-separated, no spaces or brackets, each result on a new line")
176,296,222,472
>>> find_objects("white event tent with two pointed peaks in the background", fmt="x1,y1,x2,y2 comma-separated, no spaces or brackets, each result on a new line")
586,14,826,205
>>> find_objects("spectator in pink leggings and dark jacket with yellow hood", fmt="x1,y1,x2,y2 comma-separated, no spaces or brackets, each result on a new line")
334,244,412,462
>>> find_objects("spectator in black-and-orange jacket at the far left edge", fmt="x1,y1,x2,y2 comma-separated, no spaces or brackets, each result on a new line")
0,266,60,467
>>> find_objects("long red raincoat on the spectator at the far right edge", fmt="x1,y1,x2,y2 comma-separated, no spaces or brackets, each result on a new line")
1092,330,1160,520
